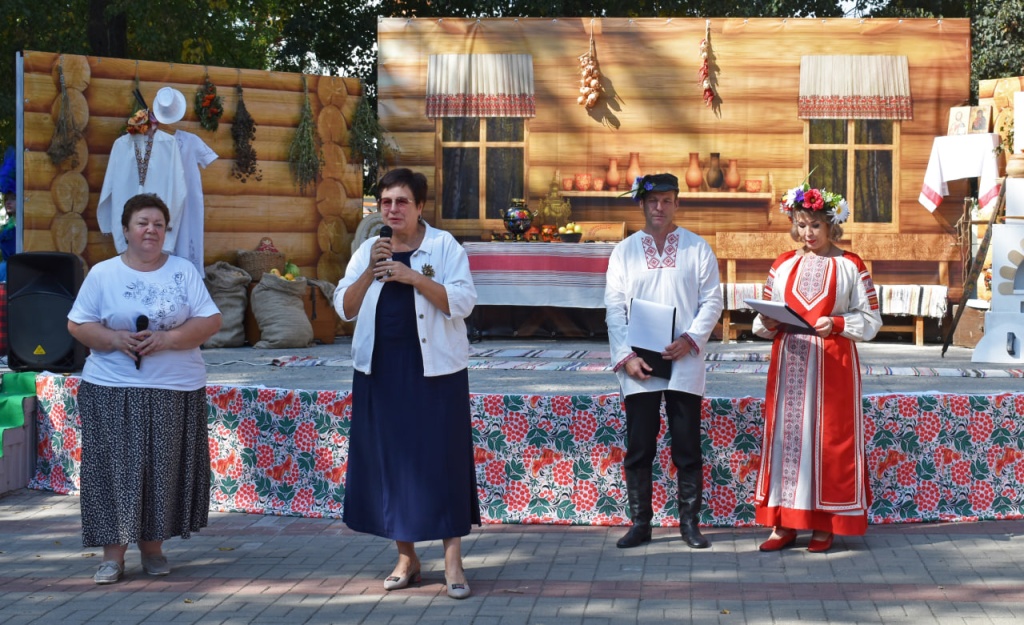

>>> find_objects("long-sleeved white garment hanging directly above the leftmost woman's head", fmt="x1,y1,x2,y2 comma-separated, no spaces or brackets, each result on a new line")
96,130,186,254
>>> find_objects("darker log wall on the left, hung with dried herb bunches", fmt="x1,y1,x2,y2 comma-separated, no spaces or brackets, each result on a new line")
24,51,362,283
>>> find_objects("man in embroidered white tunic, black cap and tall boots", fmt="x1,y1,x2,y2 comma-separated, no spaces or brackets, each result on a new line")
604,173,722,549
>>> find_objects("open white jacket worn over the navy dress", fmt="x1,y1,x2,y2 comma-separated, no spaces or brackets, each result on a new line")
334,224,476,377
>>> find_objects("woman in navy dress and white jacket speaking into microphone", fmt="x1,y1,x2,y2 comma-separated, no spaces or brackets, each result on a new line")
334,169,480,598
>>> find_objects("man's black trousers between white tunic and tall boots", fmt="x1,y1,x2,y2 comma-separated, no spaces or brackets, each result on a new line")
623,390,703,477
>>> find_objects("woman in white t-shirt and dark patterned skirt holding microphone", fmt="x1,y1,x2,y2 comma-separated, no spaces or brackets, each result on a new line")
68,194,220,584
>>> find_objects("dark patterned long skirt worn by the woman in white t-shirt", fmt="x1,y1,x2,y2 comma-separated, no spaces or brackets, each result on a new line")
78,381,210,547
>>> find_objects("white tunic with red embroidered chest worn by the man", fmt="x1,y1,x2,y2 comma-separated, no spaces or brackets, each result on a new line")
604,227,722,395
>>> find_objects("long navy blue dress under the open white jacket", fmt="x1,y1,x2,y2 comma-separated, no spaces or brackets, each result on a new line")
344,247,480,542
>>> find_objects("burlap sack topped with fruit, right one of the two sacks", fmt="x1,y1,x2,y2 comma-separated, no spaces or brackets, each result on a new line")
250,274,313,349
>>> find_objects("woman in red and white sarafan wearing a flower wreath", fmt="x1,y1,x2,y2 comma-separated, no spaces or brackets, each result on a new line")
754,184,882,552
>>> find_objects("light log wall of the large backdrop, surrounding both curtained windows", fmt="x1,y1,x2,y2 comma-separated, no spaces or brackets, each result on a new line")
378,17,971,282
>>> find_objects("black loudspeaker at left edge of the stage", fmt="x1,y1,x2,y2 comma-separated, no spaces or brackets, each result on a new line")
7,252,87,373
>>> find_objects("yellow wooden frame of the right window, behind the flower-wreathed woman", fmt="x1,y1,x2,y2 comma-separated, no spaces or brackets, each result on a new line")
804,118,902,235
